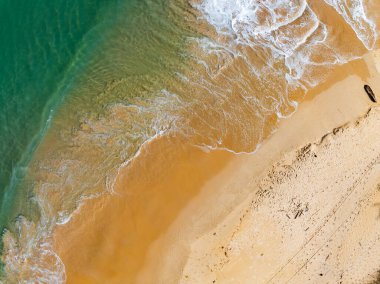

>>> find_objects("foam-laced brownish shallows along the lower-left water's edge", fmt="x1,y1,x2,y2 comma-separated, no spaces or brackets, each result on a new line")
2,89,183,283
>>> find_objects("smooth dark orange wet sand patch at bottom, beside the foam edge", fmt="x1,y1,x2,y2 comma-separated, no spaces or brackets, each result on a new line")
55,138,233,283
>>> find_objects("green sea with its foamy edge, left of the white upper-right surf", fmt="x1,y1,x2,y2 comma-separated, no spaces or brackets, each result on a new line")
0,0,194,282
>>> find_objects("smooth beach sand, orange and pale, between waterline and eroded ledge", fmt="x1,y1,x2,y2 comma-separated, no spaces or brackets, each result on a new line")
54,50,380,283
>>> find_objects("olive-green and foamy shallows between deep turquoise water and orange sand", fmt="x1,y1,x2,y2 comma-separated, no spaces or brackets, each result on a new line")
2,1,197,282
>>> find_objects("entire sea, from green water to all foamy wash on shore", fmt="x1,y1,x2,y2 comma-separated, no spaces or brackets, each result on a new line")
1,0,375,282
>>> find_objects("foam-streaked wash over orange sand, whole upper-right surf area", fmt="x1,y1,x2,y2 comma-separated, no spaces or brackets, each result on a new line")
183,0,377,152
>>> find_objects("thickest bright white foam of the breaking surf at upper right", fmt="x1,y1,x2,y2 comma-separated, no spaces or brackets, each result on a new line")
195,0,377,87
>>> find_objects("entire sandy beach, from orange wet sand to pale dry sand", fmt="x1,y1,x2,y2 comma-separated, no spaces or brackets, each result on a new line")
54,50,380,284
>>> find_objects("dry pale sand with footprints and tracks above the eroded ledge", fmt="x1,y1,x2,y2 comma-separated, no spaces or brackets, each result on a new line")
177,106,380,283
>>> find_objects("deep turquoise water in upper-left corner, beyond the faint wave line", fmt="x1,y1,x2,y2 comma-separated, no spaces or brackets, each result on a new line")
0,0,118,236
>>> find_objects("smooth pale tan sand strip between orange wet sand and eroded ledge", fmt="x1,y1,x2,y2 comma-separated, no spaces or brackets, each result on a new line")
134,52,380,283
